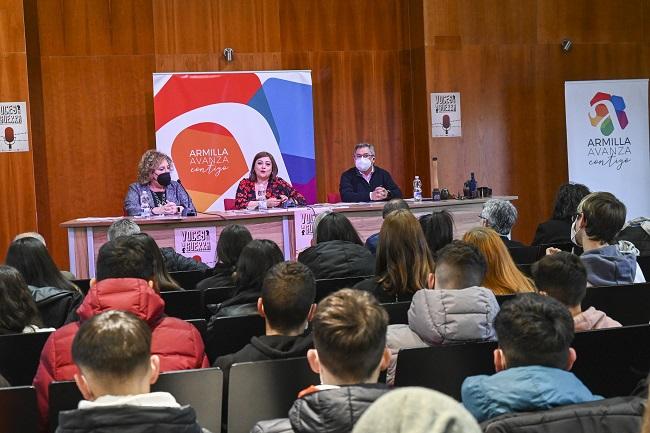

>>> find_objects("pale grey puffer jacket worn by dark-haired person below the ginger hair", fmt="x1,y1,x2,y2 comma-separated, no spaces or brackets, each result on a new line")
386,287,499,384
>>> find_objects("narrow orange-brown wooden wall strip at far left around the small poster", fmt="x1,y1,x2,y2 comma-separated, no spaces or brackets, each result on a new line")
0,0,37,255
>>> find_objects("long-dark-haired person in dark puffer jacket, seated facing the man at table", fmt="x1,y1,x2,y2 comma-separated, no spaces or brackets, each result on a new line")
298,212,375,280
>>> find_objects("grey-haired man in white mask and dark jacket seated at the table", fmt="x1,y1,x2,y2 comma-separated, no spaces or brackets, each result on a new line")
339,143,402,202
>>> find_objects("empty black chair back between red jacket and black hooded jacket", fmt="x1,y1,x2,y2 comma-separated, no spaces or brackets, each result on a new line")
204,314,265,362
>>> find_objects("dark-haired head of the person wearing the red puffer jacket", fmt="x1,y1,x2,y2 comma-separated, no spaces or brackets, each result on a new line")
96,235,154,285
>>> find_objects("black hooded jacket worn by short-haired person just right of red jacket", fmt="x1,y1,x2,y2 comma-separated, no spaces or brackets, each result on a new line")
214,334,314,375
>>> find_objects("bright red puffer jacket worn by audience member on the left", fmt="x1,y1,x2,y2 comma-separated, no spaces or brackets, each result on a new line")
34,278,210,427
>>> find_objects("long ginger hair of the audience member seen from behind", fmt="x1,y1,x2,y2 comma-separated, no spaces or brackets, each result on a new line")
463,227,535,295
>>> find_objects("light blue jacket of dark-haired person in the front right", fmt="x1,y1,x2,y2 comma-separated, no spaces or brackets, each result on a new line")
461,365,602,422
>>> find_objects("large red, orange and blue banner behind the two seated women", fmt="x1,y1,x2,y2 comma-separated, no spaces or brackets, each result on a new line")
153,71,316,212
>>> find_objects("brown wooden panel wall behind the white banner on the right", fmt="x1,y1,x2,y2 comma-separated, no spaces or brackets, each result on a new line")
424,0,650,242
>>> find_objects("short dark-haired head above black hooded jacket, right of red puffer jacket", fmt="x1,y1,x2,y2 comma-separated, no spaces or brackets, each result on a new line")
257,262,316,335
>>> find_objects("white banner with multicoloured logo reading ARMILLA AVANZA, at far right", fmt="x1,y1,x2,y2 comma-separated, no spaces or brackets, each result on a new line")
564,79,650,220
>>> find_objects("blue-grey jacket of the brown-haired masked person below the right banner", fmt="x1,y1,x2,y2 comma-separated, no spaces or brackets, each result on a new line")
580,241,637,286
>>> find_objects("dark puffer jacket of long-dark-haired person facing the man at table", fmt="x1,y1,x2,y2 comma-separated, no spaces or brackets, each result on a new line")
298,241,375,280
